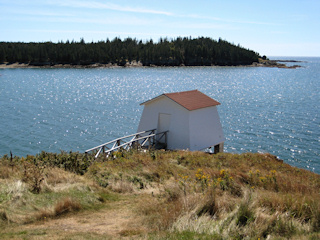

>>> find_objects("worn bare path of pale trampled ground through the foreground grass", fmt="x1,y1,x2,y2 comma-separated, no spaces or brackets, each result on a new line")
22,199,147,238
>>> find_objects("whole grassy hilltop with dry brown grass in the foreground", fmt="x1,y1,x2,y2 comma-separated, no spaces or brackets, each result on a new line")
0,151,320,239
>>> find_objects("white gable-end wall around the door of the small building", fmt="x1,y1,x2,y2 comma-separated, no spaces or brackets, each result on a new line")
138,96,190,149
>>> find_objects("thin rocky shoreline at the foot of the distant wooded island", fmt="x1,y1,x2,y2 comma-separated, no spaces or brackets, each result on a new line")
0,59,301,69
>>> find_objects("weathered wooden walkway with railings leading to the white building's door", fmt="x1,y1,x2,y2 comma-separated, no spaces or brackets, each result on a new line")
85,129,168,158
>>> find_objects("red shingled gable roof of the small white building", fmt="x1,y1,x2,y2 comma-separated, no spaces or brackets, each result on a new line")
142,90,220,111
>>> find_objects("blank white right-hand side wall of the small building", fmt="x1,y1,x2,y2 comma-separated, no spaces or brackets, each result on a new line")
189,106,225,151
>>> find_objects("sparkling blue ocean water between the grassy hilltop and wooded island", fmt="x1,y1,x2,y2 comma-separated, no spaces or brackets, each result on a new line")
0,57,320,173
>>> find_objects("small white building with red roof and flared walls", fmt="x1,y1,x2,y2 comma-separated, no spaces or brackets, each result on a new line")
138,90,225,153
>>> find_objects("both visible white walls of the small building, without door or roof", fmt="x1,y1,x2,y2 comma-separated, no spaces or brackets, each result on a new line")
138,96,225,151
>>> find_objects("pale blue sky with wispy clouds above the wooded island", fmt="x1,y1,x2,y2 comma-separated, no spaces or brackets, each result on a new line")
0,0,320,56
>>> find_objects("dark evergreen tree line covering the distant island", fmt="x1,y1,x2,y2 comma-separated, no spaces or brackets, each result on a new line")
0,37,260,66
